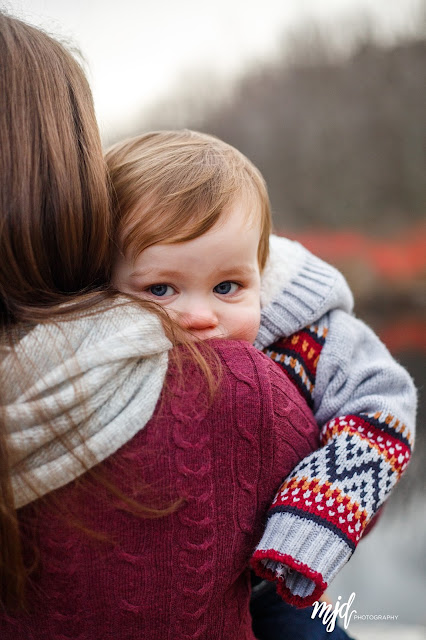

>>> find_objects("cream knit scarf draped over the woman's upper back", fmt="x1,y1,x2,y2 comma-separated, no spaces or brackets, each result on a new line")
0,303,171,507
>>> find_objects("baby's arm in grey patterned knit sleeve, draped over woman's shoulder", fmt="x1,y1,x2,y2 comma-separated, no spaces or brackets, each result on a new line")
253,238,416,606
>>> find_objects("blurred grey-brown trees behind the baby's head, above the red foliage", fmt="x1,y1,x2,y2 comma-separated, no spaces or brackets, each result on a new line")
136,25,426,235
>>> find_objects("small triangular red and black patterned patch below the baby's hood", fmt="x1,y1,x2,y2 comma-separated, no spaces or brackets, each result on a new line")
264,325,327,409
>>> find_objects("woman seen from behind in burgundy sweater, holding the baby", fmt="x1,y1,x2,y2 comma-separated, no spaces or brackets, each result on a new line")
0,15,318,640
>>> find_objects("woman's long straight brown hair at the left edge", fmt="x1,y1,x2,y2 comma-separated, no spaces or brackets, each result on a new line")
0,14,116,606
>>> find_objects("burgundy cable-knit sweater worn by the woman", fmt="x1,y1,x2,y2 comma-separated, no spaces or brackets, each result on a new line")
0,342,319,640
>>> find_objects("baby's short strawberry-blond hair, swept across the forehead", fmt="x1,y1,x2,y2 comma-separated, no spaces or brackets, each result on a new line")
106,130,271,270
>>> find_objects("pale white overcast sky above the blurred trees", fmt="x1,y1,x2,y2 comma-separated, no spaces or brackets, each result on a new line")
4,0,421,137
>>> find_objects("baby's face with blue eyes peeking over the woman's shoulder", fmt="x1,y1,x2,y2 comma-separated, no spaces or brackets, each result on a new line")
113,202,260,342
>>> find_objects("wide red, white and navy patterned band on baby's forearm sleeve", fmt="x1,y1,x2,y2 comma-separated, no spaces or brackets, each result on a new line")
270,416,410,549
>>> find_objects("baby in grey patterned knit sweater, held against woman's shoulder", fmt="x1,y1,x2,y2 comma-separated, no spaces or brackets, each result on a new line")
106,131,416,620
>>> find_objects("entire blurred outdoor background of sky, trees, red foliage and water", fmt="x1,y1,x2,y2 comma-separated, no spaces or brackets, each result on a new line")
4,0,426,640
